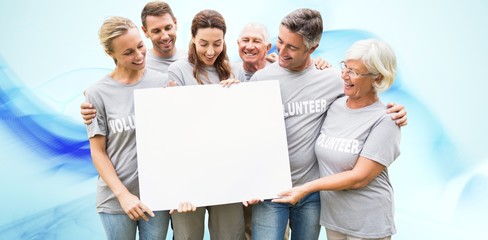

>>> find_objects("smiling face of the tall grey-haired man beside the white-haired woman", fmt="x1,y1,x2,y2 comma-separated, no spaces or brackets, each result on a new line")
276,26,316,71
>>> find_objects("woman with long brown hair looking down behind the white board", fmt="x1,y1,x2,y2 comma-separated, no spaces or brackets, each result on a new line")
168,10,245,240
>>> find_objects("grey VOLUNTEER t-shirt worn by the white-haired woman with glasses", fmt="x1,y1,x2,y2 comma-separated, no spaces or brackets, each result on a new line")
315,97,400,238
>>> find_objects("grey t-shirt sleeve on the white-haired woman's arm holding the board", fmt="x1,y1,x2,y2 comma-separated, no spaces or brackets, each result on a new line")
360,115,400,167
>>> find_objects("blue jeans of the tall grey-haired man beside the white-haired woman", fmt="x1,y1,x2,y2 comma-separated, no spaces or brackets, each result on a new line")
252,192,320,240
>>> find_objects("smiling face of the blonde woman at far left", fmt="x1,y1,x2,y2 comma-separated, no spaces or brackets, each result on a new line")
108,28,146,70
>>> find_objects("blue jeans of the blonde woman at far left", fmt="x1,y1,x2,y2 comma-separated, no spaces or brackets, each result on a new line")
99,211,169,240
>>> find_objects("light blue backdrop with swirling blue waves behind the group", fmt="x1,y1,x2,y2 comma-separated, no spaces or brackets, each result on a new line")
0,0,488,240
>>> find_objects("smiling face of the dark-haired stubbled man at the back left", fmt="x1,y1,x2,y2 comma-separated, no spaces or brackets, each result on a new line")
142,13,177,58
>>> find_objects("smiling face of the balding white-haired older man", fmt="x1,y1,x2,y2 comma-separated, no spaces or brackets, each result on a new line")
237,28,271,65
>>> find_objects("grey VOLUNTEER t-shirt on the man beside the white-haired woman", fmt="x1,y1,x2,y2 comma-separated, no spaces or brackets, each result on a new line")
250,62,343,186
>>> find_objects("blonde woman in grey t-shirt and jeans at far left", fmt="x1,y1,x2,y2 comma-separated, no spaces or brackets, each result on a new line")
85,17,169,240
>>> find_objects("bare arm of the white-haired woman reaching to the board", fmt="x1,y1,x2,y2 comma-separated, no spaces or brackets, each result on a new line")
272,156,385,204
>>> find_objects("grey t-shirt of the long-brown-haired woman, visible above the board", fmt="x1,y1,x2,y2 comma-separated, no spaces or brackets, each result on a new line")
168,59,245,86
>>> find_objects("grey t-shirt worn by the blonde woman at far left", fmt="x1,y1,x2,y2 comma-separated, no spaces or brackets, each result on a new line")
85,69,168,213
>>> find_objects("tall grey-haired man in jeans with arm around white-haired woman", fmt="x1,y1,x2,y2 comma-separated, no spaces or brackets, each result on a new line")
249,9,406,240
